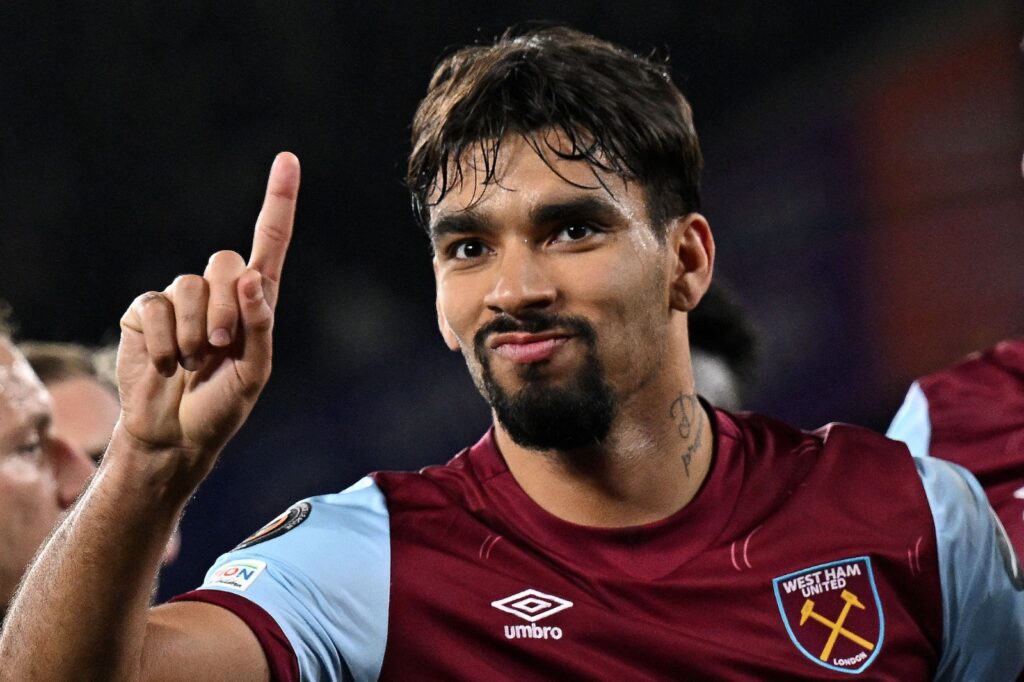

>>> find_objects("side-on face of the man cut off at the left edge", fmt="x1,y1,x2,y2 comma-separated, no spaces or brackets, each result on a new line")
0,337,94,612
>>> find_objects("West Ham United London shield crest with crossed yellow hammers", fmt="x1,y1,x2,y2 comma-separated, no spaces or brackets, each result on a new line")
772,556,886,675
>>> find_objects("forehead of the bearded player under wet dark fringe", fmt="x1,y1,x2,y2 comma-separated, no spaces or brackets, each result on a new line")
430,132,647,229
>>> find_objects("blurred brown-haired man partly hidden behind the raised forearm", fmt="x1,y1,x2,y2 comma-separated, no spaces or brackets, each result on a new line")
19,341,181,565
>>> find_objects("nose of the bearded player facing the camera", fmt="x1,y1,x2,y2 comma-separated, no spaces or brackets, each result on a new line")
483,244,558,315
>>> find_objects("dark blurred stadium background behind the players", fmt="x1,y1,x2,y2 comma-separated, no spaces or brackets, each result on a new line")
0,0,1024,596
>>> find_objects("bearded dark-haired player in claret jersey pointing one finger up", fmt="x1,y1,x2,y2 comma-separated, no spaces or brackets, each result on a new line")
0,29,1024,680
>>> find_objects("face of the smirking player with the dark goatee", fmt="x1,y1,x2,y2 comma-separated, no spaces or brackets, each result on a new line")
430,137,672,450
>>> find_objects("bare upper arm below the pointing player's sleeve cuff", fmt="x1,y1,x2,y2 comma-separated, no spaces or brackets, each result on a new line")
140,601,270,682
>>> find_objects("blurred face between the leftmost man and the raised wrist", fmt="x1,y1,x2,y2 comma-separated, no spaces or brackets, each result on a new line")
47,376,121,462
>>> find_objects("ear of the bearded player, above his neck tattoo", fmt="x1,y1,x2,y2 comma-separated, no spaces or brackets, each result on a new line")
666,213,715,312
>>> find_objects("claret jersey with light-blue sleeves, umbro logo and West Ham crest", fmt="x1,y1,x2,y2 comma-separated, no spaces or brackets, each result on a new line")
178,411,1024,681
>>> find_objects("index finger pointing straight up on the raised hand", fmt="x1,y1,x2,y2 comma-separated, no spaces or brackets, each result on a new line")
249,152,299,308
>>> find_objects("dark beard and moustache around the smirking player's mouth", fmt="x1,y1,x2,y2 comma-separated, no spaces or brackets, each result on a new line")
473,313,616,451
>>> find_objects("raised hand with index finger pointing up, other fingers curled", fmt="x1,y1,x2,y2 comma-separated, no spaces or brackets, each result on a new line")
118,152,299,463
